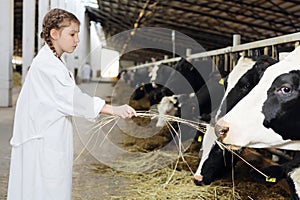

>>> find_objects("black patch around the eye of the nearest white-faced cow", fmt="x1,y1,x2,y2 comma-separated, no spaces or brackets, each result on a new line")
262,70,300,140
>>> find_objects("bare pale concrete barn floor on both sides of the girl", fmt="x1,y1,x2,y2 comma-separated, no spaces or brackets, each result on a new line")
0,82,132,200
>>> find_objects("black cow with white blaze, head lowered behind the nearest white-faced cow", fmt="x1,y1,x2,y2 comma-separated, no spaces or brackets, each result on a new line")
194,55,277,185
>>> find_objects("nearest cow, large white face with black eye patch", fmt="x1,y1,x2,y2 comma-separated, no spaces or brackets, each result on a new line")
215,48,300,199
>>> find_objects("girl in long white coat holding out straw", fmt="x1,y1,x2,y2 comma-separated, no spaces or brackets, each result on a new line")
8,9,136,200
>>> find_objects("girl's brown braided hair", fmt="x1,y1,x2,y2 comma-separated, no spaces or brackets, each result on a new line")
40,8,80,58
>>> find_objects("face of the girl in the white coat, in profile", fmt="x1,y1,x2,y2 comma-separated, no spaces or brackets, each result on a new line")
51,22,79,57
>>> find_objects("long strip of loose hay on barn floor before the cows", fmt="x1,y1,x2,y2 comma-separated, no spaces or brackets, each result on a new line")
74,80,289,200
